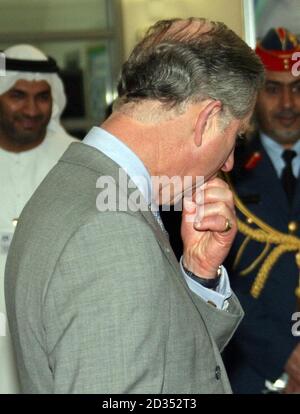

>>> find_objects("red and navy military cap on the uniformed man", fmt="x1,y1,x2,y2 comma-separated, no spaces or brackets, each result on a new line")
255,27,300,72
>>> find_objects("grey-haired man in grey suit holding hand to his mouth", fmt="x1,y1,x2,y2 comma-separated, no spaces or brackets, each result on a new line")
6,19,263,393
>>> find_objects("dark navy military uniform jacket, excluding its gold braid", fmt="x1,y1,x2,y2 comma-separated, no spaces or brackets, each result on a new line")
226,135,300,393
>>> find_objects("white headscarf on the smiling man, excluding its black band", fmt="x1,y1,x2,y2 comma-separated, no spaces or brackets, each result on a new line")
0,45,66,134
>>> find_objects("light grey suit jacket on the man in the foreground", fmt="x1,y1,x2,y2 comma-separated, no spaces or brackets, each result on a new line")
5,143,242,393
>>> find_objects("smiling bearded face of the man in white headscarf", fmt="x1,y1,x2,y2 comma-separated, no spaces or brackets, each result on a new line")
0,80,52,152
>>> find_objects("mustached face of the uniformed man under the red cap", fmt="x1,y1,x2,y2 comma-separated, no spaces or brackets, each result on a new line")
256,71,300,147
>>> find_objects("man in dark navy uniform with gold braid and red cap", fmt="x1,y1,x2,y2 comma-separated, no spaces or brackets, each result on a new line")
227,28,300,393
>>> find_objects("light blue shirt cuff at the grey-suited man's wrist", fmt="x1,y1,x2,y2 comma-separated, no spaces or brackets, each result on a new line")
180,256,232,310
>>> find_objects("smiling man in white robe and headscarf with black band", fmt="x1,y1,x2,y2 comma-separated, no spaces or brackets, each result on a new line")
0,45,75,394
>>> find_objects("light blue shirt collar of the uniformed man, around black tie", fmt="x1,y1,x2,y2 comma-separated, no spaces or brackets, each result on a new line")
260,132,300,178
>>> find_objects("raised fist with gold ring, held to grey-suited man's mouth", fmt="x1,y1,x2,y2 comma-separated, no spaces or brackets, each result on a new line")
181,178,237,278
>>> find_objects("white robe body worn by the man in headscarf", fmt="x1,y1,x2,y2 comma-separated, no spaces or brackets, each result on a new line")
0,131,75,394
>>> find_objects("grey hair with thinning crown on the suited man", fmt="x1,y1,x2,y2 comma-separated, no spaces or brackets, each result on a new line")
116,18,264,119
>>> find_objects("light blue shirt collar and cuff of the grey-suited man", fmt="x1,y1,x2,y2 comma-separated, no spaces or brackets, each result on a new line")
83,127,232,310
